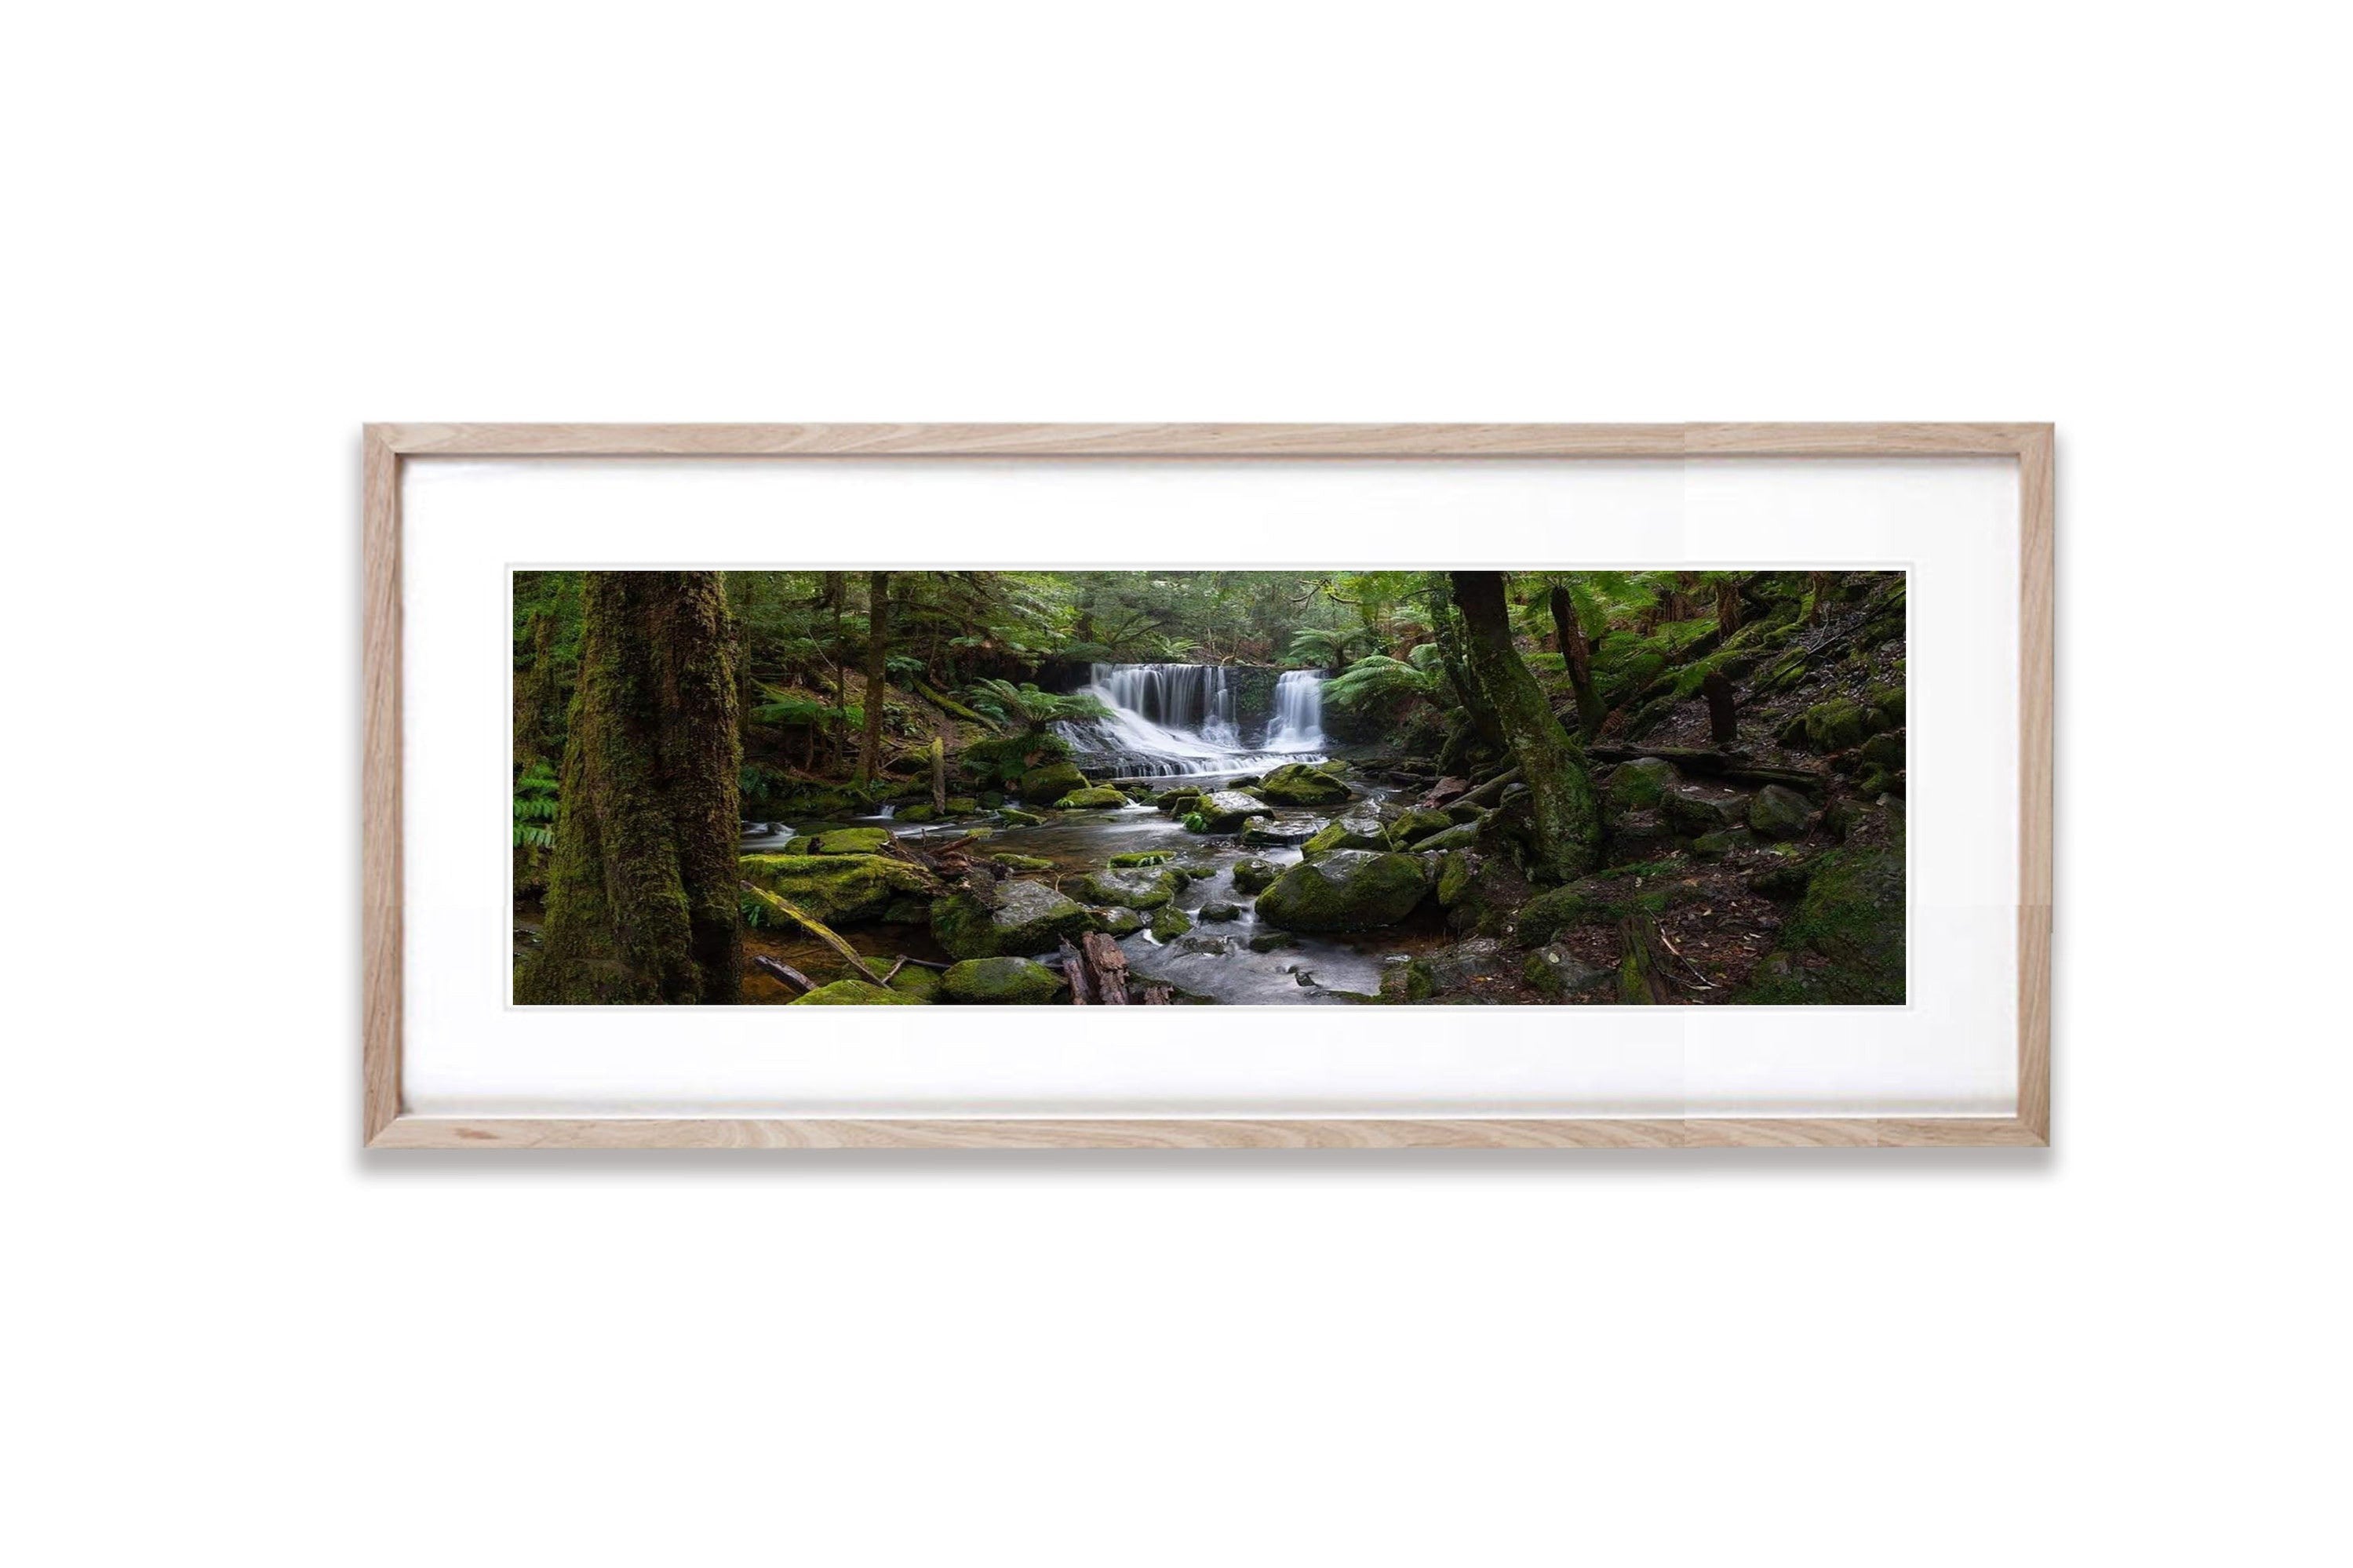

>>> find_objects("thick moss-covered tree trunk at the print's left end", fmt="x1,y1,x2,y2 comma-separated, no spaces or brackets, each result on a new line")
515,571,744,1004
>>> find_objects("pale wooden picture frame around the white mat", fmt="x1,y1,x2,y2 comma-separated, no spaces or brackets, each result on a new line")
362,423,2054,1150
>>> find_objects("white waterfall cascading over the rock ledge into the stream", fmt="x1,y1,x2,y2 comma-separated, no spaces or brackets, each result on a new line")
1054,665,1324,778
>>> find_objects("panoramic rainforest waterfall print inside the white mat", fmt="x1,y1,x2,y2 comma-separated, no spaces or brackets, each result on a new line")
513,571,1906,1006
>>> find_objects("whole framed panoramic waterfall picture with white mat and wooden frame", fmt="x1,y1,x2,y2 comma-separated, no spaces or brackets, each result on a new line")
362,423,2054,1148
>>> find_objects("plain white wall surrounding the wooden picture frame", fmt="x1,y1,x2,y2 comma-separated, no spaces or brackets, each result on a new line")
0,2,2348,1568
